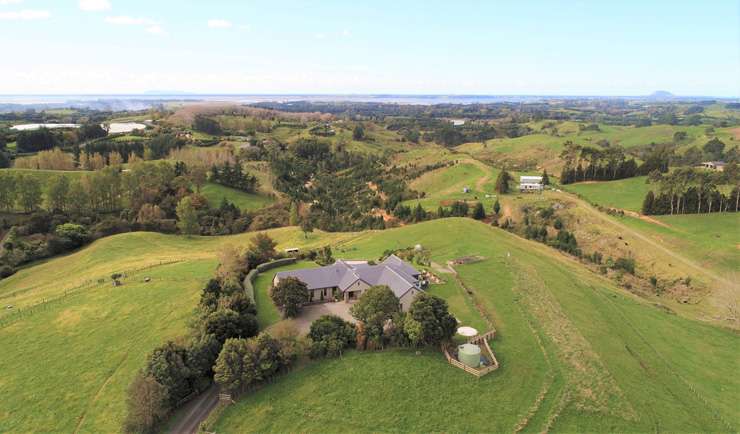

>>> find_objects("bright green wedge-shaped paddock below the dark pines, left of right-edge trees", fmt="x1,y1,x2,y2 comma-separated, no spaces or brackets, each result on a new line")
563,176,651,212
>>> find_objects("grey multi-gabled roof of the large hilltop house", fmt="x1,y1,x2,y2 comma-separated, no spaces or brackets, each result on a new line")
275,255,419,298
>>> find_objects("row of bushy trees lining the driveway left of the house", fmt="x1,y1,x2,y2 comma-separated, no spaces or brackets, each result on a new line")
124,234,280,432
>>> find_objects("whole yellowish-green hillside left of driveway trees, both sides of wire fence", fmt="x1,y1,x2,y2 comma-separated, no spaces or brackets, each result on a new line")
0,229,355,432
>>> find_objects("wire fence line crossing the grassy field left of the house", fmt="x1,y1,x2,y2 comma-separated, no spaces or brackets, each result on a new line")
0,258,185,329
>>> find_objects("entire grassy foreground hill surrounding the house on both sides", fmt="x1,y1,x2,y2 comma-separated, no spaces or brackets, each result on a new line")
0,219,740,432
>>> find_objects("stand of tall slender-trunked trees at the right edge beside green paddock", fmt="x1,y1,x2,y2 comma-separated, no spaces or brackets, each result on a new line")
642,163,740,215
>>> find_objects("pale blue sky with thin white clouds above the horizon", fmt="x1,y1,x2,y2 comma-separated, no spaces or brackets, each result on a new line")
0,0,740,97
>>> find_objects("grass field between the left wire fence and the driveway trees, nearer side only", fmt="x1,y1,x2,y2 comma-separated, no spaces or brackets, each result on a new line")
0,258,211,432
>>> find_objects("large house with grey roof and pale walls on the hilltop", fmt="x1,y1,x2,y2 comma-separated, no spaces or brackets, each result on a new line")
272,255,423,310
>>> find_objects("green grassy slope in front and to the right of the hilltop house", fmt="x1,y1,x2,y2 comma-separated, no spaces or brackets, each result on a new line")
211,219,740,432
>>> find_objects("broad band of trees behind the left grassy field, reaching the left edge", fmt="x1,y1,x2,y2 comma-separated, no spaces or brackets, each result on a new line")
0,162,280,274
